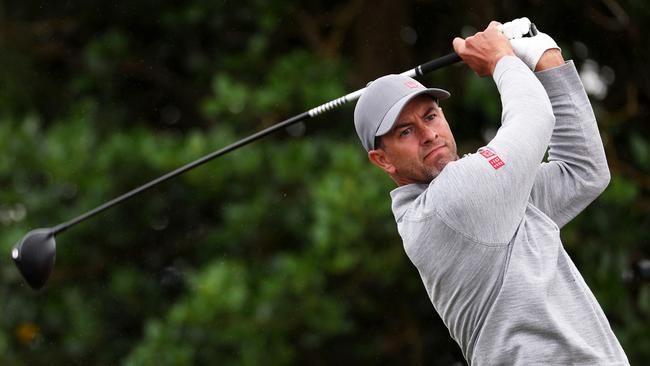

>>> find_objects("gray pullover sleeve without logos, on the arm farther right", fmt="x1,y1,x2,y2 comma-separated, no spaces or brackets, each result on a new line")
531,61,610,227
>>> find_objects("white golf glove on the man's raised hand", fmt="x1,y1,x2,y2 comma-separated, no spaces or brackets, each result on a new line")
499,18,560,71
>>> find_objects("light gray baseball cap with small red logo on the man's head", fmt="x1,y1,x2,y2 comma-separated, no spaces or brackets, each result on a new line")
354,75,450,151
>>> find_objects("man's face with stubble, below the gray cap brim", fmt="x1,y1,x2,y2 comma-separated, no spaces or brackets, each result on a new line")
368,95,458,186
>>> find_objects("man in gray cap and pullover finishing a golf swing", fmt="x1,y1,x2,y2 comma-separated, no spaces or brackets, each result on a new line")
354,20,628,365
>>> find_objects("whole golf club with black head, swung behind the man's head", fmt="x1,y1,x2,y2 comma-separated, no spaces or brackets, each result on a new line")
11,23,537,290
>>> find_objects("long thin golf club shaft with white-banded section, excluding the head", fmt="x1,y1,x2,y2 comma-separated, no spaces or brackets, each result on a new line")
52,52,460,235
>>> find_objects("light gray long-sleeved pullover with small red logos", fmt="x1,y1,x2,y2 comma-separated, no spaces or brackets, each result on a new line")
391,56,628,365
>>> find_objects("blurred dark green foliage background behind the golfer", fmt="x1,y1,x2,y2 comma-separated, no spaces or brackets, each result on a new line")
0,0,650,365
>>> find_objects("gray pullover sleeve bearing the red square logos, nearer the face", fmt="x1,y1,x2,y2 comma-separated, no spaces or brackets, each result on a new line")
422,56,555,243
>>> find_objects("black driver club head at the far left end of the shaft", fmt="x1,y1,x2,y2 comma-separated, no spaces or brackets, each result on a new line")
11,228,56,290
